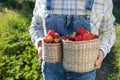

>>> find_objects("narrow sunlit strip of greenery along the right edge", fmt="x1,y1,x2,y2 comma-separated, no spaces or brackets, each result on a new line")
107,24,120,80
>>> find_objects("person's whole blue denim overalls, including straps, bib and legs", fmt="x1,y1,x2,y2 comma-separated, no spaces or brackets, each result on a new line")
42,0,96,80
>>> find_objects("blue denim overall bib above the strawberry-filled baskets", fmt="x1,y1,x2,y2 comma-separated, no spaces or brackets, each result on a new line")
45,14,91,36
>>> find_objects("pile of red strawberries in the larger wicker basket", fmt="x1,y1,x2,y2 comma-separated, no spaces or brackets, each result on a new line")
63,28,95,41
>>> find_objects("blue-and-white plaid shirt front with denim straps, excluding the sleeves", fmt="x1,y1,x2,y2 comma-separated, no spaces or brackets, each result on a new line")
40,0,104,35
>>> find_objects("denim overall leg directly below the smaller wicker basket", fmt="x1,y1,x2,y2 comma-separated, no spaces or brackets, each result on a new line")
42,62,66,80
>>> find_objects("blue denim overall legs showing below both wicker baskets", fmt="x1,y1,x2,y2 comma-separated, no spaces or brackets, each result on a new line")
42,62,96,80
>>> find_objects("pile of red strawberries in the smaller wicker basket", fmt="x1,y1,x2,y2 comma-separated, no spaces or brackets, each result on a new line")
43,30,62,44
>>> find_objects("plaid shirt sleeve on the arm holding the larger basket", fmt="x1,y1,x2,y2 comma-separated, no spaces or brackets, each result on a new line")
99,0,116,57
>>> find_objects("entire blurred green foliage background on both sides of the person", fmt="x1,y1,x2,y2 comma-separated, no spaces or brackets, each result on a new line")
0,0,120,80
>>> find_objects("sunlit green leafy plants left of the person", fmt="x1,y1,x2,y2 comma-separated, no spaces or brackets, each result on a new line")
0,6,42,80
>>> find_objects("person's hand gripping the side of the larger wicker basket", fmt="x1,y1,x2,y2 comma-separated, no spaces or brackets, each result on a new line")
95,50,104,69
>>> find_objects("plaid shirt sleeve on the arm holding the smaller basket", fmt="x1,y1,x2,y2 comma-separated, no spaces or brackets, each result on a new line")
29,0,44,48
